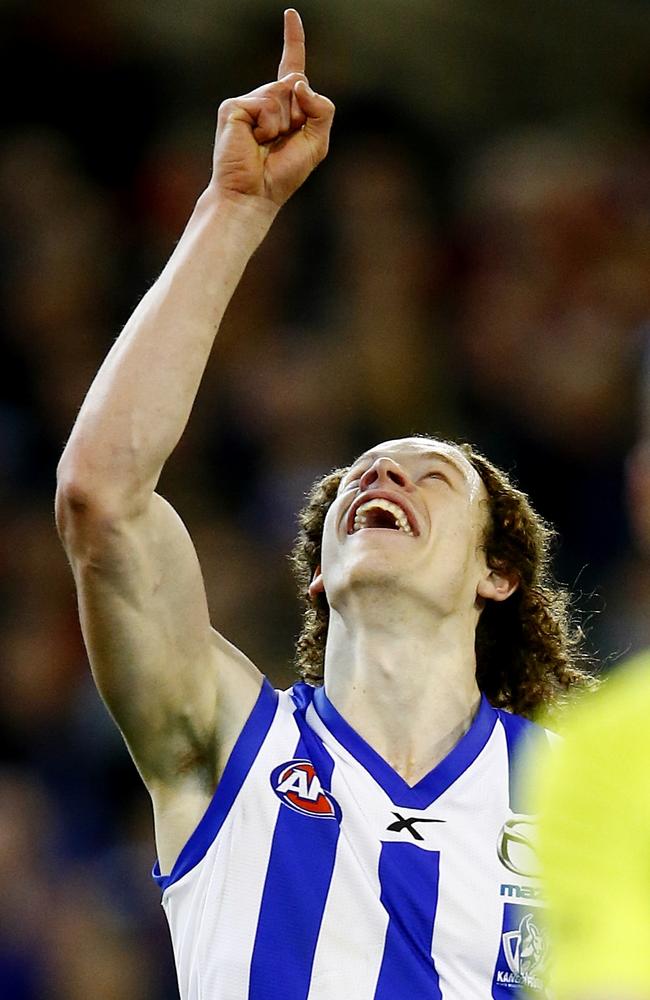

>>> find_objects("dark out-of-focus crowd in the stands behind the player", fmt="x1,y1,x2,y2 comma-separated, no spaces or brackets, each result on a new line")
0,3,650,1000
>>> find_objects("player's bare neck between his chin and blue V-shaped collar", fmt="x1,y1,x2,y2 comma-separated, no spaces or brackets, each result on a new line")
325,602,480,784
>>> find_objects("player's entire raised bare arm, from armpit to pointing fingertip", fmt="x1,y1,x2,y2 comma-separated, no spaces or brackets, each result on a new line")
56,10,334,876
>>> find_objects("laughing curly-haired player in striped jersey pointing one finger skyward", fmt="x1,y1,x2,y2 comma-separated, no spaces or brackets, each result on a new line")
57,10,582,1000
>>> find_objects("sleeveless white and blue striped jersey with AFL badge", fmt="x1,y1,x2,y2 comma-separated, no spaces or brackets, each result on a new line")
154,681,545,1000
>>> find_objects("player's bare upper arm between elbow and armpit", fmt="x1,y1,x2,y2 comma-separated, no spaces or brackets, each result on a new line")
66,495,258,786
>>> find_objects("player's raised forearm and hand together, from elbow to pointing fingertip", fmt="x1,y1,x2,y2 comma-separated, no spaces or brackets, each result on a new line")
57,9,334,530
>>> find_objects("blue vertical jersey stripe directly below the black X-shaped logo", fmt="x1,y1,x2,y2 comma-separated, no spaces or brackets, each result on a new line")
374,844,442,1000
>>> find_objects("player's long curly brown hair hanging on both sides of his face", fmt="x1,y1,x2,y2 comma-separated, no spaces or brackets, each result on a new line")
291,439,596,718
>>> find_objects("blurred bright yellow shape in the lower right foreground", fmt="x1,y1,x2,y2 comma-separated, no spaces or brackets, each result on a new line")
538,652,650,1000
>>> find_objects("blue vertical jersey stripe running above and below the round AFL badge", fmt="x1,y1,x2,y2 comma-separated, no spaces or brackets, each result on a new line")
248,728,339,1000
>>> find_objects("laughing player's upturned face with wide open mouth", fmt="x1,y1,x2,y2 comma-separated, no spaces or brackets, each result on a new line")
311,438,510,613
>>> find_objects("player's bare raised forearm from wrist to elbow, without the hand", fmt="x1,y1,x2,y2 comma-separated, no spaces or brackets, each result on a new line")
59,190,277,513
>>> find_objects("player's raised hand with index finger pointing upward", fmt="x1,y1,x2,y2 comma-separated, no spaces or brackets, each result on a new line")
211,10,334,206
